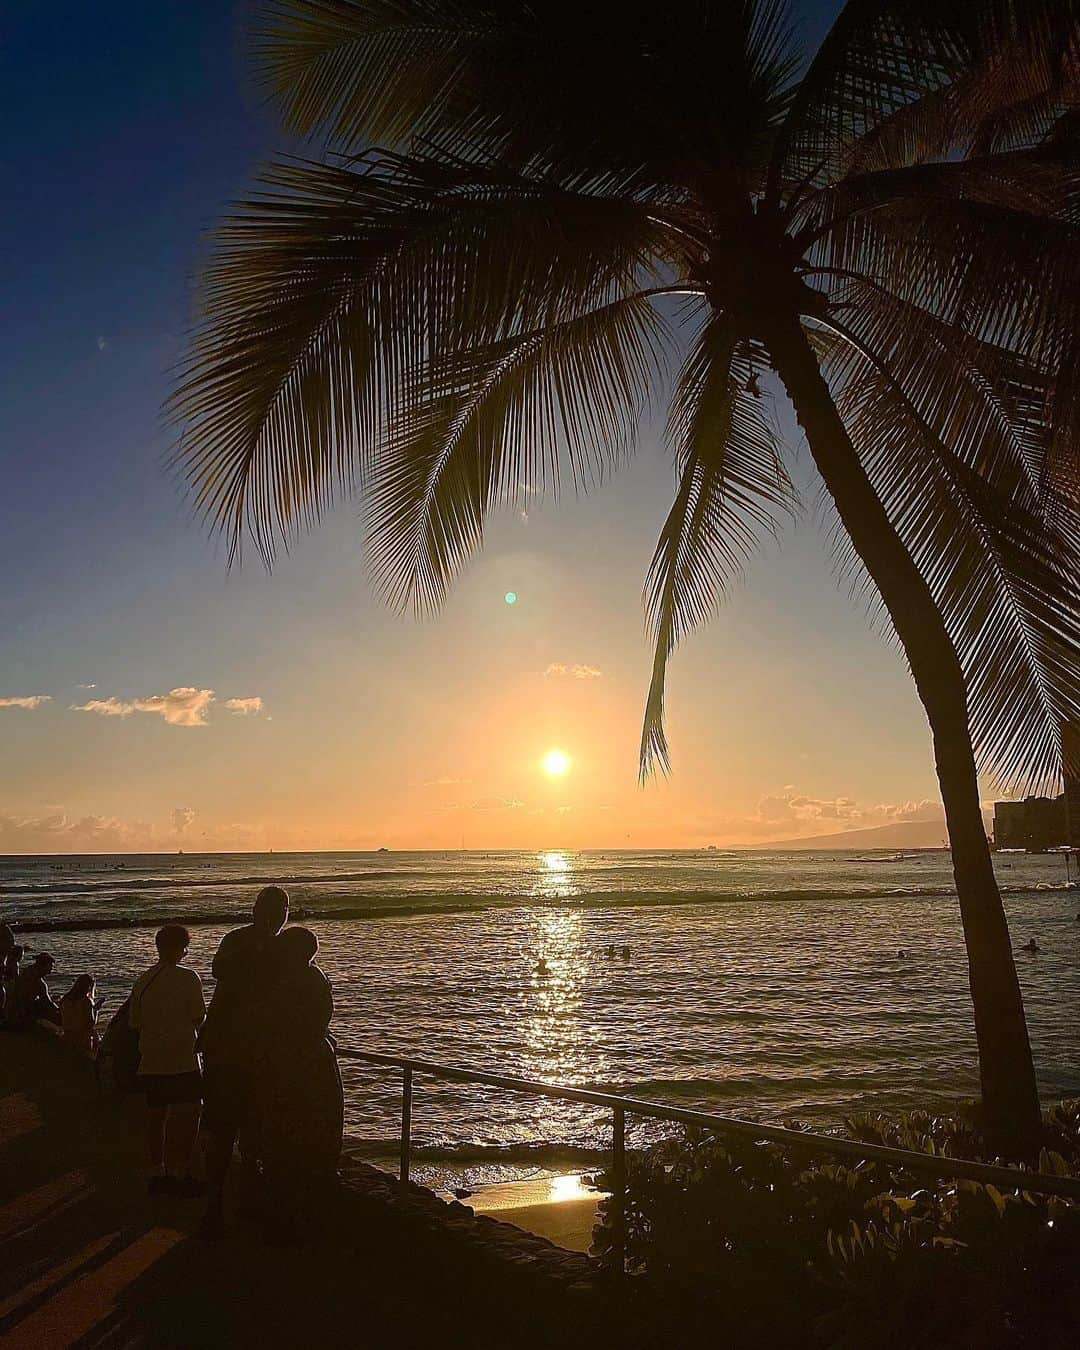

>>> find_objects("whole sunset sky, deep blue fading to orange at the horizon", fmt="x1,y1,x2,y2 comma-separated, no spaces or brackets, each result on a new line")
0,0,982,853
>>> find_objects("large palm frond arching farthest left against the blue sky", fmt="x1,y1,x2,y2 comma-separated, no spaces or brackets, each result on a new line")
170,155,684,562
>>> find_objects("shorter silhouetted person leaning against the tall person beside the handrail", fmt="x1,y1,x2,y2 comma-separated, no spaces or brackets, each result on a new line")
258,927,343,1236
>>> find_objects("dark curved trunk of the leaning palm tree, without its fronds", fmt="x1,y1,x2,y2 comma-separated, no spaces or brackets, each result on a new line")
767,316,1040,1157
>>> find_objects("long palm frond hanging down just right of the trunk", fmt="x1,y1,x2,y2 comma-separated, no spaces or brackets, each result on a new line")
832,312,1080,790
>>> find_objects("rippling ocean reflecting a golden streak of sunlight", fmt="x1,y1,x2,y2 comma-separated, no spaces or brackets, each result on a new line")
0,849,1080,1184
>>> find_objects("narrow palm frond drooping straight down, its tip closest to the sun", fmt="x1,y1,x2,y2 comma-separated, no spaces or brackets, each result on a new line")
640,315,794,776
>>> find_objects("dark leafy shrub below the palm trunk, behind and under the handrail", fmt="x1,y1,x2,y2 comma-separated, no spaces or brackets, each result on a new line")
594,1102,1080,1350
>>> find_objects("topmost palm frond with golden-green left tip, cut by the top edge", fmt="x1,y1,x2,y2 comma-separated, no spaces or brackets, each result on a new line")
257,0,797,190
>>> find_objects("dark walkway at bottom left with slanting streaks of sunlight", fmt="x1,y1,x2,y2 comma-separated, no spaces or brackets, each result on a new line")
0,1033,607,1350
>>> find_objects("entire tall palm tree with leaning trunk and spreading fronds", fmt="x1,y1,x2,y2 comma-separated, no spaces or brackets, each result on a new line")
171,0,1080,1154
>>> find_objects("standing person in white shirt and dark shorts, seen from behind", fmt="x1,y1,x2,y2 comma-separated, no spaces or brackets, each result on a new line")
128,923,207,1196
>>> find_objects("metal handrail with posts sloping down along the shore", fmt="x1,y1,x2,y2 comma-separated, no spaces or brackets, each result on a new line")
338,1046,1080,1269
